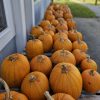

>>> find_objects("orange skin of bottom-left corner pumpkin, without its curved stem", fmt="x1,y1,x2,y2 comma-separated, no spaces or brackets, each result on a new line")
0,91,28,100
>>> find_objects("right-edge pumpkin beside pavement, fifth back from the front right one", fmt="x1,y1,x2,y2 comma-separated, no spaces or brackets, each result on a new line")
68,30,82,42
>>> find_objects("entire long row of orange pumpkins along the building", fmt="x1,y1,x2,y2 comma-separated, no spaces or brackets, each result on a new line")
0,3,100,100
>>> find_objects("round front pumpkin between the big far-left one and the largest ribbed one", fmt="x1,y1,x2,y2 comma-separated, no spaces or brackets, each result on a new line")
21,71,49,100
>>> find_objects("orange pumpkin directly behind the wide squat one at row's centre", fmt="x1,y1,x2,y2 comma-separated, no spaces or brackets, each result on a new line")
53,37,72,51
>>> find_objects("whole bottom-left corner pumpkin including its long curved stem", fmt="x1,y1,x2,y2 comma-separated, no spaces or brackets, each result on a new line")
0,78,28,100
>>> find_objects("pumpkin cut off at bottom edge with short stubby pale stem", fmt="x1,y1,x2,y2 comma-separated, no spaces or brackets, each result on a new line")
45,91,75,100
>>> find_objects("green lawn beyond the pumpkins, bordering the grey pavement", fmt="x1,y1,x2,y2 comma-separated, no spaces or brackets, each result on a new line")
54,0,96,18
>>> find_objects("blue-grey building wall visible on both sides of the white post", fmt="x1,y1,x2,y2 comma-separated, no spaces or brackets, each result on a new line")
0,0,51,63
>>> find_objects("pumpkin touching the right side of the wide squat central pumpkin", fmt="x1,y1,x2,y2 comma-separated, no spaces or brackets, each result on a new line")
72,49,87,64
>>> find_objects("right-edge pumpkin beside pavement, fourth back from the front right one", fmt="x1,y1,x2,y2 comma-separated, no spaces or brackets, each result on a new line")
73,41,88,52
